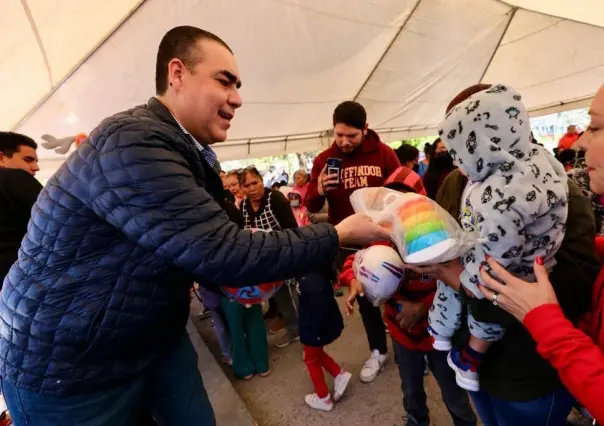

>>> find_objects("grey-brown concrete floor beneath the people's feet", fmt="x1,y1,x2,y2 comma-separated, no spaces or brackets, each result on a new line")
194,292,482,426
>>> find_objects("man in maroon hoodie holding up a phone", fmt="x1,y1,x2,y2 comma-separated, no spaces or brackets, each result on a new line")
304,101,400,383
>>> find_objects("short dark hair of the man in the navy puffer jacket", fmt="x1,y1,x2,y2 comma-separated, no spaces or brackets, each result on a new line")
155,26,233,95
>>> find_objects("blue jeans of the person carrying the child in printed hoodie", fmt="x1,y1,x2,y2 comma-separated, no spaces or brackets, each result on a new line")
470,389,575,426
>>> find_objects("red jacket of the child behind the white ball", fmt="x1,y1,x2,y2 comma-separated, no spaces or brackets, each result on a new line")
340,242,436,352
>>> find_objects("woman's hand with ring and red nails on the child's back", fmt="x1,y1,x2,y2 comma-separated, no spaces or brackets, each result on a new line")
478,257,558,322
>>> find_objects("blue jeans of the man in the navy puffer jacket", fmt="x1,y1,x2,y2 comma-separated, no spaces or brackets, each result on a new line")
2,334,216,426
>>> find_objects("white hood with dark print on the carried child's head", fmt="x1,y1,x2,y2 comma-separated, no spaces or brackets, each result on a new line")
438,84,534,181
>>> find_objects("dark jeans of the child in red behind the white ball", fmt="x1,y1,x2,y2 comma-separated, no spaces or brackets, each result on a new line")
392,339,476,426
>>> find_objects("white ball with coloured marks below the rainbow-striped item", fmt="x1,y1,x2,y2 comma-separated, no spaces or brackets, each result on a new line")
352,246,405,306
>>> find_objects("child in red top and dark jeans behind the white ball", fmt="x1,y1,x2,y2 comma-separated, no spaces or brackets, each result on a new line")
340,166,476,426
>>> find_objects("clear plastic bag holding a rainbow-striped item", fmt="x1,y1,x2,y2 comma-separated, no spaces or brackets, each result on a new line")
350,188,479,265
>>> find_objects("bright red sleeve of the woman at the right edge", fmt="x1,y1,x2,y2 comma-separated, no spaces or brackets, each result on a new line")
524,304,604,423
